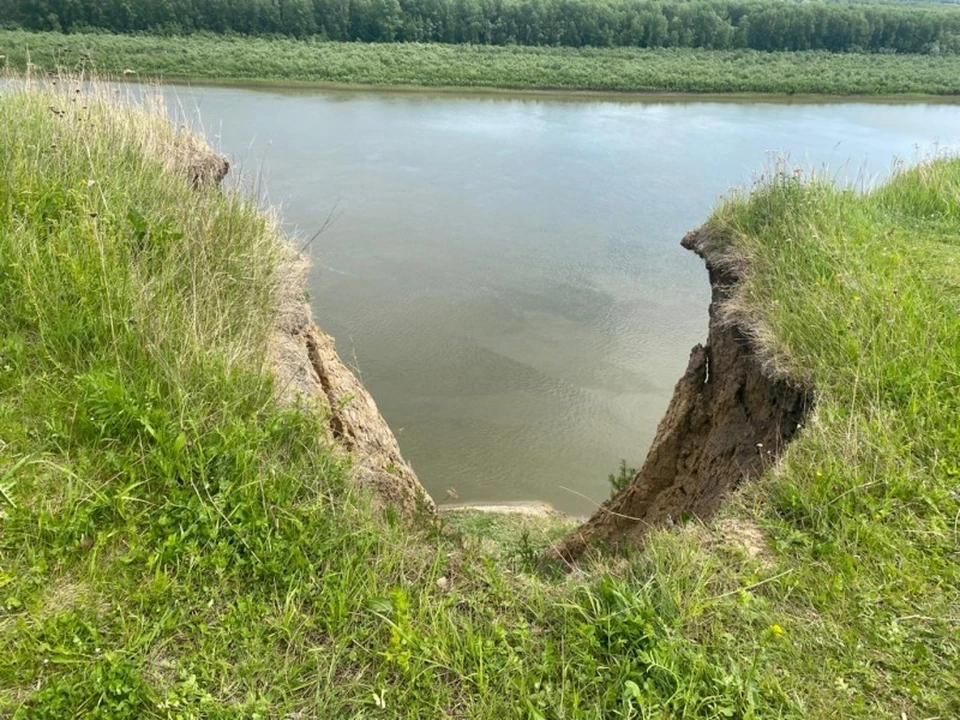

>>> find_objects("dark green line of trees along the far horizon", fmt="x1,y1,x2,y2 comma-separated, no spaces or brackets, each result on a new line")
0,0,960,53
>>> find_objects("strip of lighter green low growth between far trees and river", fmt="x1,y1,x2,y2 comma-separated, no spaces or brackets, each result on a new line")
0,31,960,95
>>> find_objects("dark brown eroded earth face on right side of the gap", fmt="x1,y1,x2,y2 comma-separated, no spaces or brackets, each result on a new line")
550,232,812,562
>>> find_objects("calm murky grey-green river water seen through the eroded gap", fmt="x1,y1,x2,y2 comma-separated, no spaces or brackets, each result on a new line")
169,88,960,514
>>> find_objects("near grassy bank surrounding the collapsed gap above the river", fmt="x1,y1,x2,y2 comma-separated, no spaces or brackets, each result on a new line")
0,81,960,718
